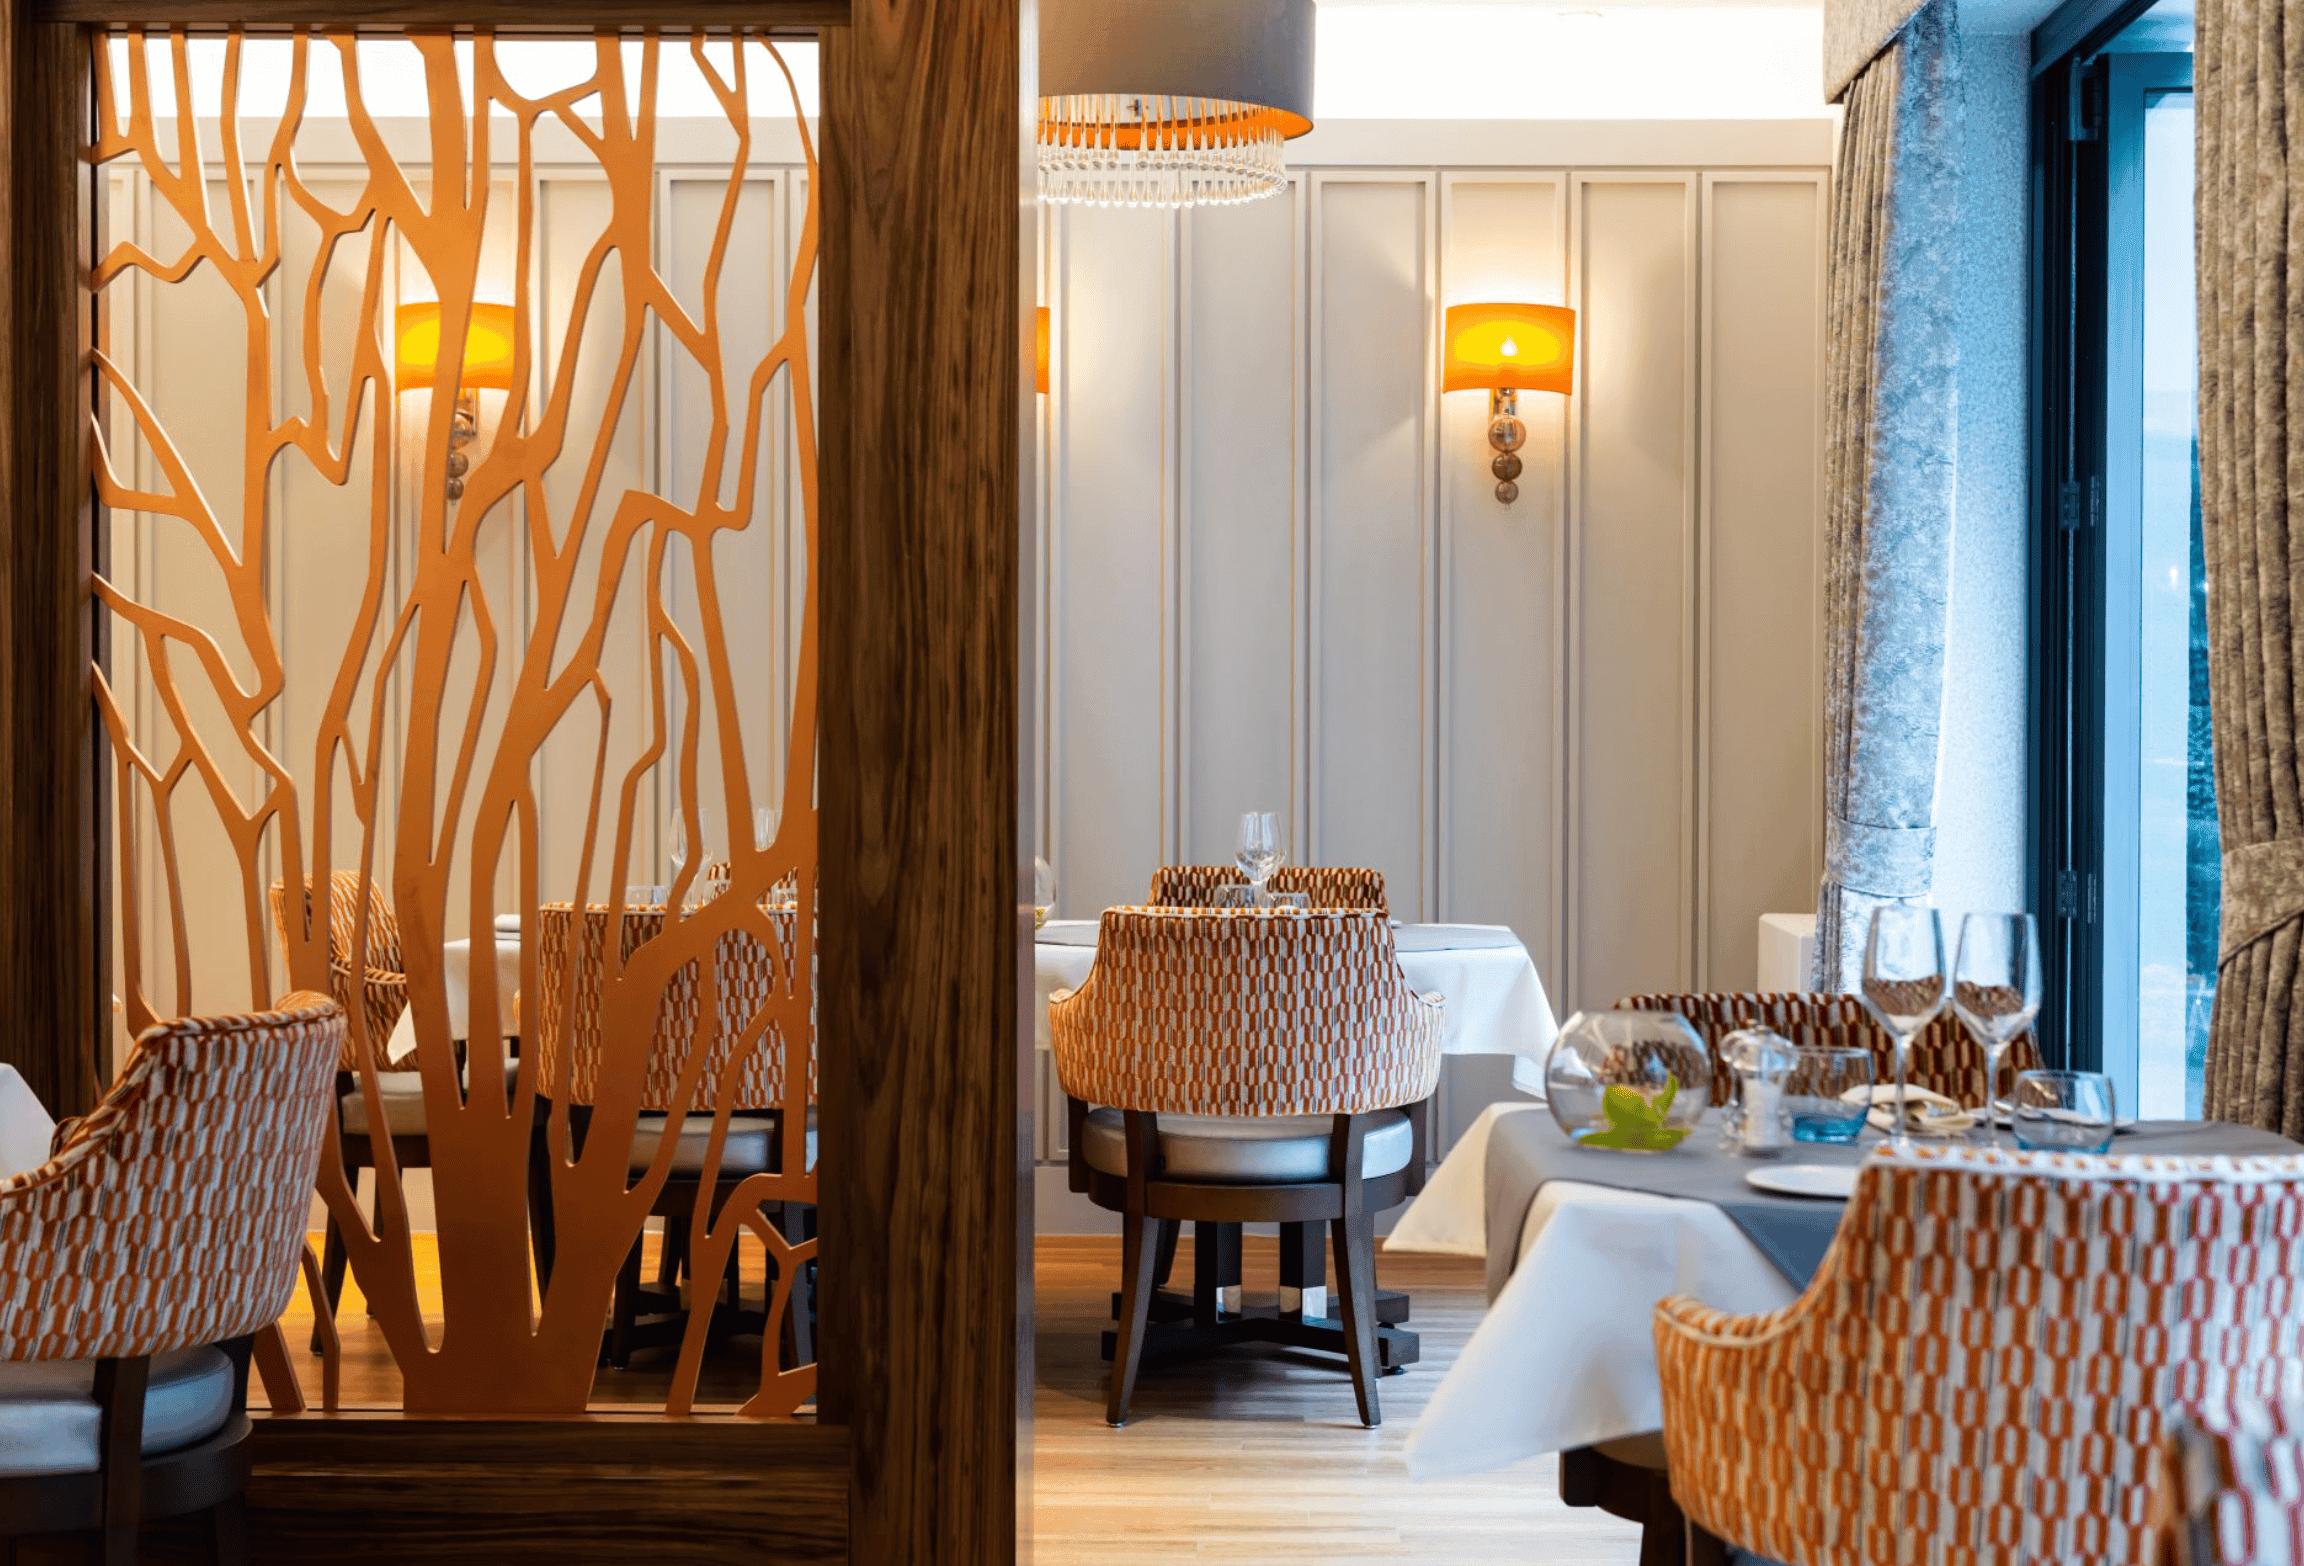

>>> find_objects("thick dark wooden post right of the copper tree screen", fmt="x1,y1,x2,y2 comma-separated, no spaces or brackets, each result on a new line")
818,0,1030,1566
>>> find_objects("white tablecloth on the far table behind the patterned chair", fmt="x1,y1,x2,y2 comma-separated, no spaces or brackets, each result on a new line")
1032,919,1560,1092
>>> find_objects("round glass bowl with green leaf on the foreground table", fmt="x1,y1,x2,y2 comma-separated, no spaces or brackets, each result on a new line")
1544,1011,1712,1154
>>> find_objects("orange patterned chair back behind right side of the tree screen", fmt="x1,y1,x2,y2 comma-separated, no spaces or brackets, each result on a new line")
521,903,816,1112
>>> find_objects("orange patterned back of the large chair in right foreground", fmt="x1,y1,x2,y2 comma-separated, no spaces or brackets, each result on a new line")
1654,1147,2304,1566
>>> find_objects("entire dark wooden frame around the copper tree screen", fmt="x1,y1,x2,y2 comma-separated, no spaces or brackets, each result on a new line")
0,0,1034,1566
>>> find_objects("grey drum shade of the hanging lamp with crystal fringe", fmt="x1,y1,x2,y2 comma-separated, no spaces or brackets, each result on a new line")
1039,0,1313,136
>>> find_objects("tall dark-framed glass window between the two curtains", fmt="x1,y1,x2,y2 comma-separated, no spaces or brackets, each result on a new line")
2032,0,2219,1117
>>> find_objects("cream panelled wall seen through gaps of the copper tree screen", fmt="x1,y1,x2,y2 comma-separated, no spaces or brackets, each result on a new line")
104,122,806,1031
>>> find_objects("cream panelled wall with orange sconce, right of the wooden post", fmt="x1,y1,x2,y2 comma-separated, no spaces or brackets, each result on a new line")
1041,143,1825,1174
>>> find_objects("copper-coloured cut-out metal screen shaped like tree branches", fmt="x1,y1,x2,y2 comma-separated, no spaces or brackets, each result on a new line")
88,32,818,1414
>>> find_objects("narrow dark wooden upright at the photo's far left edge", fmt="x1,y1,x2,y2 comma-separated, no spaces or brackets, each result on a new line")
0,0,106,1115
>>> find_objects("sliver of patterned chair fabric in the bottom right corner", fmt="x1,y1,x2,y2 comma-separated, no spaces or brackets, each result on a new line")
2152,1402,2304,1566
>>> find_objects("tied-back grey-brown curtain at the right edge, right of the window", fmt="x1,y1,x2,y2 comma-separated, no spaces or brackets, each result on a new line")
2193,0,2304,1138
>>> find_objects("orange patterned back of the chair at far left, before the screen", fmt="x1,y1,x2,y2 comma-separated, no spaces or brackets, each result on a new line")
0,993,343,1361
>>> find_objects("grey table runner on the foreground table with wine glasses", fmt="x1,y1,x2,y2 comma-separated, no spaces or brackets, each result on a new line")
1486,1110,2304,1299
